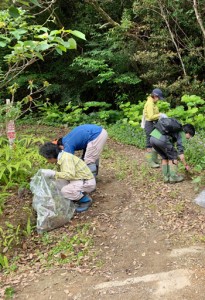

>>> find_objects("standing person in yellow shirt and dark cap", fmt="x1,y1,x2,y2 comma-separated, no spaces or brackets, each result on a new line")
143,88,166,168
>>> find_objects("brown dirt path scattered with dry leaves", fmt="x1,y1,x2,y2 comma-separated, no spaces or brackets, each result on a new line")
2,141,205,300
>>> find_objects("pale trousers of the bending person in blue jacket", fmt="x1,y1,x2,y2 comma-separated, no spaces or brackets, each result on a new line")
84,128,108,165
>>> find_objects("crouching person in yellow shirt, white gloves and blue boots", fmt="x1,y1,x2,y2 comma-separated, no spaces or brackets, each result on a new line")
39,142,96,212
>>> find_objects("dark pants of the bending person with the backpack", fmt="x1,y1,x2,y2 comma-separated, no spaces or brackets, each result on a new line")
150,135,178,161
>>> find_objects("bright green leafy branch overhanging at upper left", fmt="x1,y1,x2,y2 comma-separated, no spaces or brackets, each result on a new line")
0,7,85,71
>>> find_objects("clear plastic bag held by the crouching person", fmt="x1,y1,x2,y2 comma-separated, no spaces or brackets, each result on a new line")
30,170,75,233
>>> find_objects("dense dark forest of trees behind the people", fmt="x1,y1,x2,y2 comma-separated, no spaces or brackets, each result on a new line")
0,0,205,115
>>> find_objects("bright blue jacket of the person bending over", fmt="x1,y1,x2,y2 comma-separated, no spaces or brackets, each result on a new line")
62,124,102,154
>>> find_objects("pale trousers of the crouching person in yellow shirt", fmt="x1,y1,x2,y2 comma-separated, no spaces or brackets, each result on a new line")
57,178,96,201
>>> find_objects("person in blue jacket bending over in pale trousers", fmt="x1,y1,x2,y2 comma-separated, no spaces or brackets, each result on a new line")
53,124,108,176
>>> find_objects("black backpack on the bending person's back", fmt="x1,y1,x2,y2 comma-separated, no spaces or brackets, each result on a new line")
154,118,183,135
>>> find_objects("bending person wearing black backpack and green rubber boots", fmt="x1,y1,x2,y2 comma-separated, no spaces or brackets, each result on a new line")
150,118,195,183
